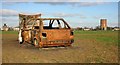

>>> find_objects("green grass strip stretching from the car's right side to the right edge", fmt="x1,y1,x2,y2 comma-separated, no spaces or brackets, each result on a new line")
74,31,120,46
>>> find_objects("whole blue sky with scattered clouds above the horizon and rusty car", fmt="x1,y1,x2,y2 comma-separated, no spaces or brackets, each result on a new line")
0,0,118,27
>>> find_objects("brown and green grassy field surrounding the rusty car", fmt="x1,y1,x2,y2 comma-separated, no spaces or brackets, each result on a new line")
0,31,118,63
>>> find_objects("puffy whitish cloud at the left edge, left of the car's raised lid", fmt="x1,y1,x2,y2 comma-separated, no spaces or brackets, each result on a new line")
0,9,18,16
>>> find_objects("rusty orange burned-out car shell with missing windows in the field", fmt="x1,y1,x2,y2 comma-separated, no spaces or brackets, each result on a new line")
19,14,74,47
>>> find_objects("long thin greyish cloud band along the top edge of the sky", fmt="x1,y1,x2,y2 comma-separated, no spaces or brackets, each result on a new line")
3,0,110,7
